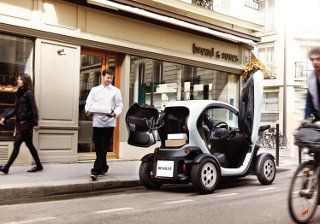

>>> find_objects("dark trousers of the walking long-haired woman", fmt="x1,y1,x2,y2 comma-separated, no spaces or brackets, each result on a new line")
4,126,42,169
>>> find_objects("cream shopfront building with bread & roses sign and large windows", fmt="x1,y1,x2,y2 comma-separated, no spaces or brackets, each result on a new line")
0,0,262,163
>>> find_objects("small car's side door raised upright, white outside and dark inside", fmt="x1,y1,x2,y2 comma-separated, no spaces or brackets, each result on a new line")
238,70,263,144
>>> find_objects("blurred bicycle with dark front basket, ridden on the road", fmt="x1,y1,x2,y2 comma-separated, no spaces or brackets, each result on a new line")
288,123,320,223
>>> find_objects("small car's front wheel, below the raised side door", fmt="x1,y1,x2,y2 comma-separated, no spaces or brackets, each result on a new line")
257,156,276,185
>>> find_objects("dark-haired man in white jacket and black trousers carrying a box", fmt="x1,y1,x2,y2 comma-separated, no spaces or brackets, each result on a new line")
85,69,123,181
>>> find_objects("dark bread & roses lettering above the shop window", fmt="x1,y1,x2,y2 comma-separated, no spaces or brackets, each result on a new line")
192,43,239,62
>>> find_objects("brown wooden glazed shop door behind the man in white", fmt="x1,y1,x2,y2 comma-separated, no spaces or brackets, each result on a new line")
78,50,120,160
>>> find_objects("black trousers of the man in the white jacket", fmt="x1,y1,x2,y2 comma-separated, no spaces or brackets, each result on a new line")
91,127,114,175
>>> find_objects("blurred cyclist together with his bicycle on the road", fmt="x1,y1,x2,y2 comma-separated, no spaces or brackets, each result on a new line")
288,47,320,223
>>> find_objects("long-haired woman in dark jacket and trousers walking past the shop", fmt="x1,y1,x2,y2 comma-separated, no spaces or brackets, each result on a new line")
0,74,43,174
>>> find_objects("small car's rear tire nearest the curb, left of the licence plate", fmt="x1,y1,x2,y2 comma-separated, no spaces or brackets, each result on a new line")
139,161,162,189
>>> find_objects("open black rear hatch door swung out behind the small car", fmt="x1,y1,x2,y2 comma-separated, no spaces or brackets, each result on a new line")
126,103,159,147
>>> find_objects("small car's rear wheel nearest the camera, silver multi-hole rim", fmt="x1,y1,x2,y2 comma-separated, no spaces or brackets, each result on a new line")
191,158,220,194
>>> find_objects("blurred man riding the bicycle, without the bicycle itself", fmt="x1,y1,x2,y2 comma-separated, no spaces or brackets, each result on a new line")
302,47,320,123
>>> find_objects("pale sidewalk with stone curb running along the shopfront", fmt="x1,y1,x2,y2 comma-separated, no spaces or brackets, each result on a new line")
0,149,298,204
